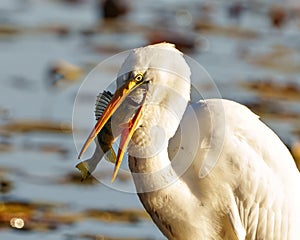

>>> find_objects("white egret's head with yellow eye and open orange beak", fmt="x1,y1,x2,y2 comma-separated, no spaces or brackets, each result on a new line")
79,43,190,179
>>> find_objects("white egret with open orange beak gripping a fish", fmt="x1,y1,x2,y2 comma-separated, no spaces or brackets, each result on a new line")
80,43,300,240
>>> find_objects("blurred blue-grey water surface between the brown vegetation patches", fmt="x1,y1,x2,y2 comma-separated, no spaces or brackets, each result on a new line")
0,0,300,240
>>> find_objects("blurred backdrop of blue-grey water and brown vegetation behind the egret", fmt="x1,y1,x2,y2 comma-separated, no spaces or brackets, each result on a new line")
0,0,300,240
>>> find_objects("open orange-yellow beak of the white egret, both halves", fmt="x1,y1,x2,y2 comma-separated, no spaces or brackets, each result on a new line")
78,74,146,182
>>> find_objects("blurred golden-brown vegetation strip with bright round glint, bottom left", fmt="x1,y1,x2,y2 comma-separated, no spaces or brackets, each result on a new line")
0,201,150,232
